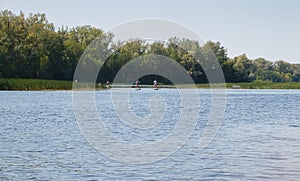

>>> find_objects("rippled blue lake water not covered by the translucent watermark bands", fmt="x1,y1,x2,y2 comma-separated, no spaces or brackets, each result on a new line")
0,89,300,180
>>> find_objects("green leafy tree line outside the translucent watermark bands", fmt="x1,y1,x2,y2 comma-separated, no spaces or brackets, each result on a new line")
0,10,300,83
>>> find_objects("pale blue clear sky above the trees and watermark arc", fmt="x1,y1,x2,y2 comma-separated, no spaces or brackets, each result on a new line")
0,0,300,63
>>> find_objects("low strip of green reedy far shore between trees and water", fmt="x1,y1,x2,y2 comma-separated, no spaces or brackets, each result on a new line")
0,79,300,90
